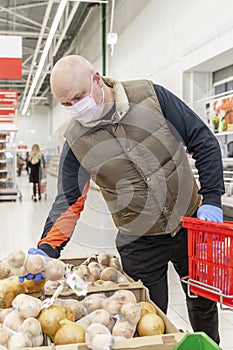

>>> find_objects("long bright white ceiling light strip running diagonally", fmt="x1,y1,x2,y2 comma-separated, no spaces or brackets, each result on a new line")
22,0,68,115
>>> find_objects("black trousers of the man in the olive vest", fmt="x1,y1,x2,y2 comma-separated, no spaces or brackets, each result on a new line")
116,228,220,344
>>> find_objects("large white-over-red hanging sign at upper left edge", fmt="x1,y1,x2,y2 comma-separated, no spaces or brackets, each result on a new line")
0,35,22,79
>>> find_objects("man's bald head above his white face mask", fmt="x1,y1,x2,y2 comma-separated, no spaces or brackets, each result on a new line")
50,55,95,102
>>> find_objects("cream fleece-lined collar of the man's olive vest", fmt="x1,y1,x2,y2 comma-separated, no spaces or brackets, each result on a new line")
102,76,130,120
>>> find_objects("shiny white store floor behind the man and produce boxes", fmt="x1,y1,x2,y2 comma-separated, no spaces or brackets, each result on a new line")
0,172,233,350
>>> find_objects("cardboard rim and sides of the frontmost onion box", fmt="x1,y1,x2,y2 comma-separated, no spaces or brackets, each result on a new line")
45,285,185,350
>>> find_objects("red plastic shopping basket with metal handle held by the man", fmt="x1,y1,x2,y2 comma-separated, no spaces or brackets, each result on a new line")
181,217,233,308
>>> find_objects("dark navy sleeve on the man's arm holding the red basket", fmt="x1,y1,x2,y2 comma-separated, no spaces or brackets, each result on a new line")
154,84,224,207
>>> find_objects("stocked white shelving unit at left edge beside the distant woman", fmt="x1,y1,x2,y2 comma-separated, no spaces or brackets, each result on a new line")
0,131,18,200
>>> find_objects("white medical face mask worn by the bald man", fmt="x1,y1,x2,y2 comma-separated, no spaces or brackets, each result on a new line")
66,79,104,125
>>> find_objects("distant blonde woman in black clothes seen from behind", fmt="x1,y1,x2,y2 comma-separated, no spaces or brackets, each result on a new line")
26,144,43,202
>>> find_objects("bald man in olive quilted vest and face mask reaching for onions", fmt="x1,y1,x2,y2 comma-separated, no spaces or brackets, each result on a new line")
38,55,224,343
